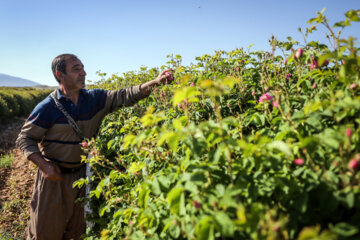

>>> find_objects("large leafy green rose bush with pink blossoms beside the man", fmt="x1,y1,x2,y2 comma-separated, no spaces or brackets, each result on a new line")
75,11,360,240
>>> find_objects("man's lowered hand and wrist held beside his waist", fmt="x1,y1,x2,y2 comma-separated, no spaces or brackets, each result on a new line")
28,153,64,181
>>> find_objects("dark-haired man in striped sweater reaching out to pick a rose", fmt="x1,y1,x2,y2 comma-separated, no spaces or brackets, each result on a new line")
16,54,173,240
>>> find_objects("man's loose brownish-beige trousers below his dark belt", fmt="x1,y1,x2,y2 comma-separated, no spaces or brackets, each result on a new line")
27,168,86,240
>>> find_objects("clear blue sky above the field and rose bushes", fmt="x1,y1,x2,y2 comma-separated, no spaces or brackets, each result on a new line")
0,0,360,86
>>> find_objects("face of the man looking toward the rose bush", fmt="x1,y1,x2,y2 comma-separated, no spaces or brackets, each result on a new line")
60,57,86,90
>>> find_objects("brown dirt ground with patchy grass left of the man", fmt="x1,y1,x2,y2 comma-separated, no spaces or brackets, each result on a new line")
0,118,36,240
